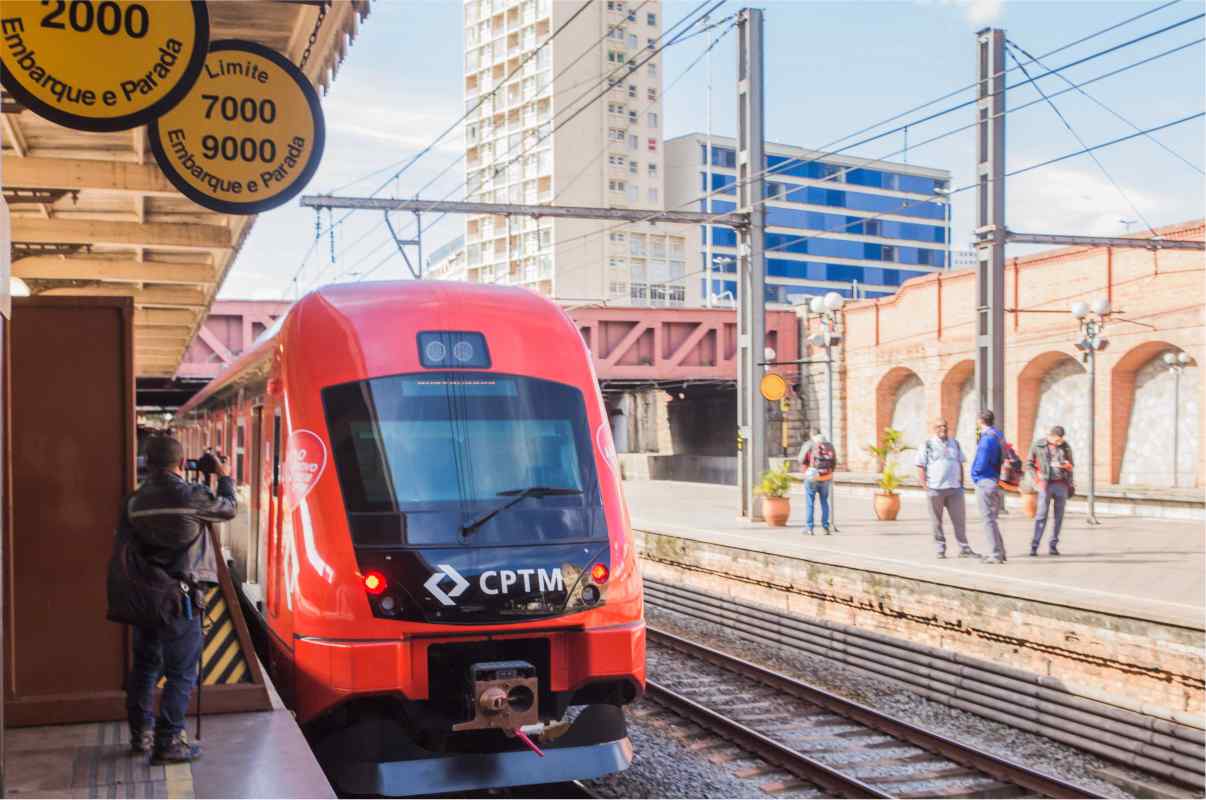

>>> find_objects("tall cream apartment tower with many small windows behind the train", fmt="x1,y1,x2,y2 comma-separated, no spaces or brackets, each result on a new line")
428,0,687,304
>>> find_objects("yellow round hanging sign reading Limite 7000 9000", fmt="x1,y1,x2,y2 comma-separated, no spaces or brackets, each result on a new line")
150,40,326,214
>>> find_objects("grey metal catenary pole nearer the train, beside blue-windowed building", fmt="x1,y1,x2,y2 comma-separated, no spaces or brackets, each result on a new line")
733,8,767,520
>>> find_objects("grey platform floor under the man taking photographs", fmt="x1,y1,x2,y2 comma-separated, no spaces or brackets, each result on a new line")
5,691,335,799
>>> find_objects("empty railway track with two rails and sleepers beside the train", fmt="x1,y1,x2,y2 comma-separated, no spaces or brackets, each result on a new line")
642,627,1100,798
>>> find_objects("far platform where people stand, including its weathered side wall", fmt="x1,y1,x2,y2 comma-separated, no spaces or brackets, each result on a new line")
624,480,1206,714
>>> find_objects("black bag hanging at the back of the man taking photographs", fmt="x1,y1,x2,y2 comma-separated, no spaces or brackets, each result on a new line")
105,525,187,627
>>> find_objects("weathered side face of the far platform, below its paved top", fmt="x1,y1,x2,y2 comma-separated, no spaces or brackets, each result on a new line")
636,531,1204,713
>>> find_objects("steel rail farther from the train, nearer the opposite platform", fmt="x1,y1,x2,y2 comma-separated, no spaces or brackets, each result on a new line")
645,627,1101,798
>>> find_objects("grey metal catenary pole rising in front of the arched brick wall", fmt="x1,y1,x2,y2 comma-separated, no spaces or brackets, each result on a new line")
976,28,1006,431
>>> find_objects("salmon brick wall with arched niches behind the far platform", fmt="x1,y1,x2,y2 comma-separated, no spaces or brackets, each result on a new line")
820,221,1206,486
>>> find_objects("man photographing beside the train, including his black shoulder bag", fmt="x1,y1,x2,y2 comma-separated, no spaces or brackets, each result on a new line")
109,436,236,764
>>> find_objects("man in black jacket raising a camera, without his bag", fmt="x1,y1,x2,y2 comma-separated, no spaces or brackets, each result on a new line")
121,436,236,764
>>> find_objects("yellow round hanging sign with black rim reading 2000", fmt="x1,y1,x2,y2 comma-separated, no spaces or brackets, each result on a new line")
0,0,210,130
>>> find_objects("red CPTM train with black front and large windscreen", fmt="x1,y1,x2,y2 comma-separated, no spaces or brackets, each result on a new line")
176,281,645,795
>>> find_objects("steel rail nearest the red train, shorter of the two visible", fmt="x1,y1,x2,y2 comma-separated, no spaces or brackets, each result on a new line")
645,679,892,798
